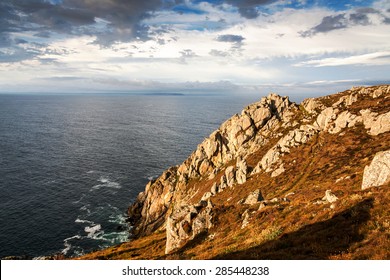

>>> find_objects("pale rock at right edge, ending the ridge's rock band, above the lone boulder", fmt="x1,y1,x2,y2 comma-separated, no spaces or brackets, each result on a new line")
360,109,390,136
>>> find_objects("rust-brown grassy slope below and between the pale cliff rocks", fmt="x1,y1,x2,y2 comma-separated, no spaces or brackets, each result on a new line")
77,88,390,259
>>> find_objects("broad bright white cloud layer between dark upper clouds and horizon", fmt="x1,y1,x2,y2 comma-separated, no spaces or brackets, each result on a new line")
0,1,390,93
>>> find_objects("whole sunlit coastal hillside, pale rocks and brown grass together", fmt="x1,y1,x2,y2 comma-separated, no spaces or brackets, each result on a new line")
77,85,390,259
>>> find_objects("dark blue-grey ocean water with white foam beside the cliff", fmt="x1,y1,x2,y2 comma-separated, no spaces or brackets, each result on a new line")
0,94,260,258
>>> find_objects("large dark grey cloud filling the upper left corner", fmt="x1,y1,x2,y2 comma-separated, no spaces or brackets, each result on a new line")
0,0,165,45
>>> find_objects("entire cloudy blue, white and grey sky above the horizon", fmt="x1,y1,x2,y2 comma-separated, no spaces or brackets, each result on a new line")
0,0,390,95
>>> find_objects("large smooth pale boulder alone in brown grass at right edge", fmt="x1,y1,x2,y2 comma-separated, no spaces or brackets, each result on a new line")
362,150,390,190
